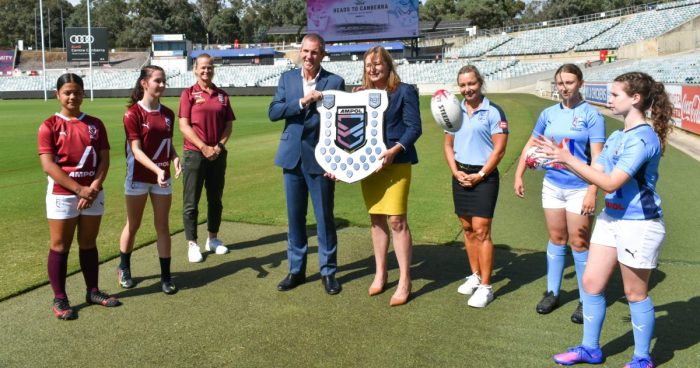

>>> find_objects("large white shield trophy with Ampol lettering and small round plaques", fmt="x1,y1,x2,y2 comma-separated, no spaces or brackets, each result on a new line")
315,89,389,183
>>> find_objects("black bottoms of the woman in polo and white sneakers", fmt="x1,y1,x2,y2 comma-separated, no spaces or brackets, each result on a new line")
452,164,500,218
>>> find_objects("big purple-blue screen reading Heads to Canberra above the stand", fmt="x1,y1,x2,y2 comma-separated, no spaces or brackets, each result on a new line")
306,0,419,42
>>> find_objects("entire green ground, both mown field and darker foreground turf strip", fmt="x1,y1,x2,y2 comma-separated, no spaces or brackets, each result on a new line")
0,94,700,367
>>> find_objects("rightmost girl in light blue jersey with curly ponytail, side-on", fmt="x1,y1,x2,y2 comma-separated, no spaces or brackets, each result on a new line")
536,72,673,368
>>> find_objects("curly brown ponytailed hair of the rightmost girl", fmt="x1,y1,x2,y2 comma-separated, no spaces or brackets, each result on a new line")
615,72,673,152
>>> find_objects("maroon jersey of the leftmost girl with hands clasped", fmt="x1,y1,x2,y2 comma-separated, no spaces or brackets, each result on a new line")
38,113,109,195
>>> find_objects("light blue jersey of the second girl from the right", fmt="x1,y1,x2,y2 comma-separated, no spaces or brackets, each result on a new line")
532,101,605,189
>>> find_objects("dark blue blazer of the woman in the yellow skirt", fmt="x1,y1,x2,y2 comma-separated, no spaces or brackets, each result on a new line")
384,83,423,164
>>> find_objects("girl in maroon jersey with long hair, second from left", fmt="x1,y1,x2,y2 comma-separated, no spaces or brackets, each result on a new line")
117,65,181,294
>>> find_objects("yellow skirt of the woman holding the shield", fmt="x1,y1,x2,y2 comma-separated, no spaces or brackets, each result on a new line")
362,163,411,215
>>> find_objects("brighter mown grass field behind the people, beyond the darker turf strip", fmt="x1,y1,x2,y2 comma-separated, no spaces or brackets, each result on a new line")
0,94,700,300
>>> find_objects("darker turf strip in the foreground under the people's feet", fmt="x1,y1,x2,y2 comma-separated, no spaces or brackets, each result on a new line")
0,222,700,367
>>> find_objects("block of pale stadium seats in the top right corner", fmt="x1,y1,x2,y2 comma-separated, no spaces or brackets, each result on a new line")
576,1,700,51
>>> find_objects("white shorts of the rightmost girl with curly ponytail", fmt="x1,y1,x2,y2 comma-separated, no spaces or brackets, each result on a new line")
591,212,666,269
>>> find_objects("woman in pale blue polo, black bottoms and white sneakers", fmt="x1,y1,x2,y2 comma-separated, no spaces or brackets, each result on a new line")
445,65,508,308
